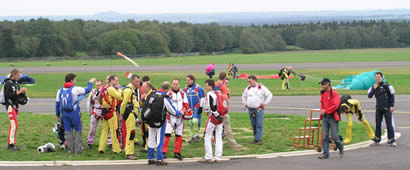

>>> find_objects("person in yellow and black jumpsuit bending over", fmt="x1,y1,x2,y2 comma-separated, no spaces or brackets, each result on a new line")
340,99,374,144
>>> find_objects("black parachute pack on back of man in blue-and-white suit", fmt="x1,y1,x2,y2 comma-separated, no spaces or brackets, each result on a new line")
141,93,168,128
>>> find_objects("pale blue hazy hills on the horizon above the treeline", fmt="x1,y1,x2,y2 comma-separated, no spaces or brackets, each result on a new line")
0,9,410,25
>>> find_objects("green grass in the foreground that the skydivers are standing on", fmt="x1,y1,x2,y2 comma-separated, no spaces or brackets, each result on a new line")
0,113,368,161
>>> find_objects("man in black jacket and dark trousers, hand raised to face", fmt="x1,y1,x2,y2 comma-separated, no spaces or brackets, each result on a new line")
368,72,397,147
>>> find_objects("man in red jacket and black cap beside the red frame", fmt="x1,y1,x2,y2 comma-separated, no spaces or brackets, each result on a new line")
318,78,343,159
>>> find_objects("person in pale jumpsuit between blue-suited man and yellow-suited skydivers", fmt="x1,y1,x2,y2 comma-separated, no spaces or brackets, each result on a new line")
87,80,112,149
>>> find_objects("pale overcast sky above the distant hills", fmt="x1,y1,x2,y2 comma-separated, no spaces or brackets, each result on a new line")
0,0,410,16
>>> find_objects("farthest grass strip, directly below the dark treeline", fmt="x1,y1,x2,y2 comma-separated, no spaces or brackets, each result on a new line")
0,48,410,67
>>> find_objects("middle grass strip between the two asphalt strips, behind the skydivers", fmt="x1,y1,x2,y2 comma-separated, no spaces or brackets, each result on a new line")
5,67,410,97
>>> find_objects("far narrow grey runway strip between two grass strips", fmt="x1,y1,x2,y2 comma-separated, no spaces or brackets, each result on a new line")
0,61,410,74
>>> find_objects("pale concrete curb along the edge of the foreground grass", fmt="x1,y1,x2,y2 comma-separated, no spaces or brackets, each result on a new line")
0,132,401,167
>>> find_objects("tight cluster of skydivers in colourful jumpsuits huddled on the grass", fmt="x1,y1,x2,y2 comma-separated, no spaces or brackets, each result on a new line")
52,72,240,165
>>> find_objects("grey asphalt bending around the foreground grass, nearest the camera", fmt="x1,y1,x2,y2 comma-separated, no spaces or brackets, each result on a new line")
0,95,410,170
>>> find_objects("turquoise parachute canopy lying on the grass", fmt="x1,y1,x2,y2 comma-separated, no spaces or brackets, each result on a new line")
334,70,385,90
